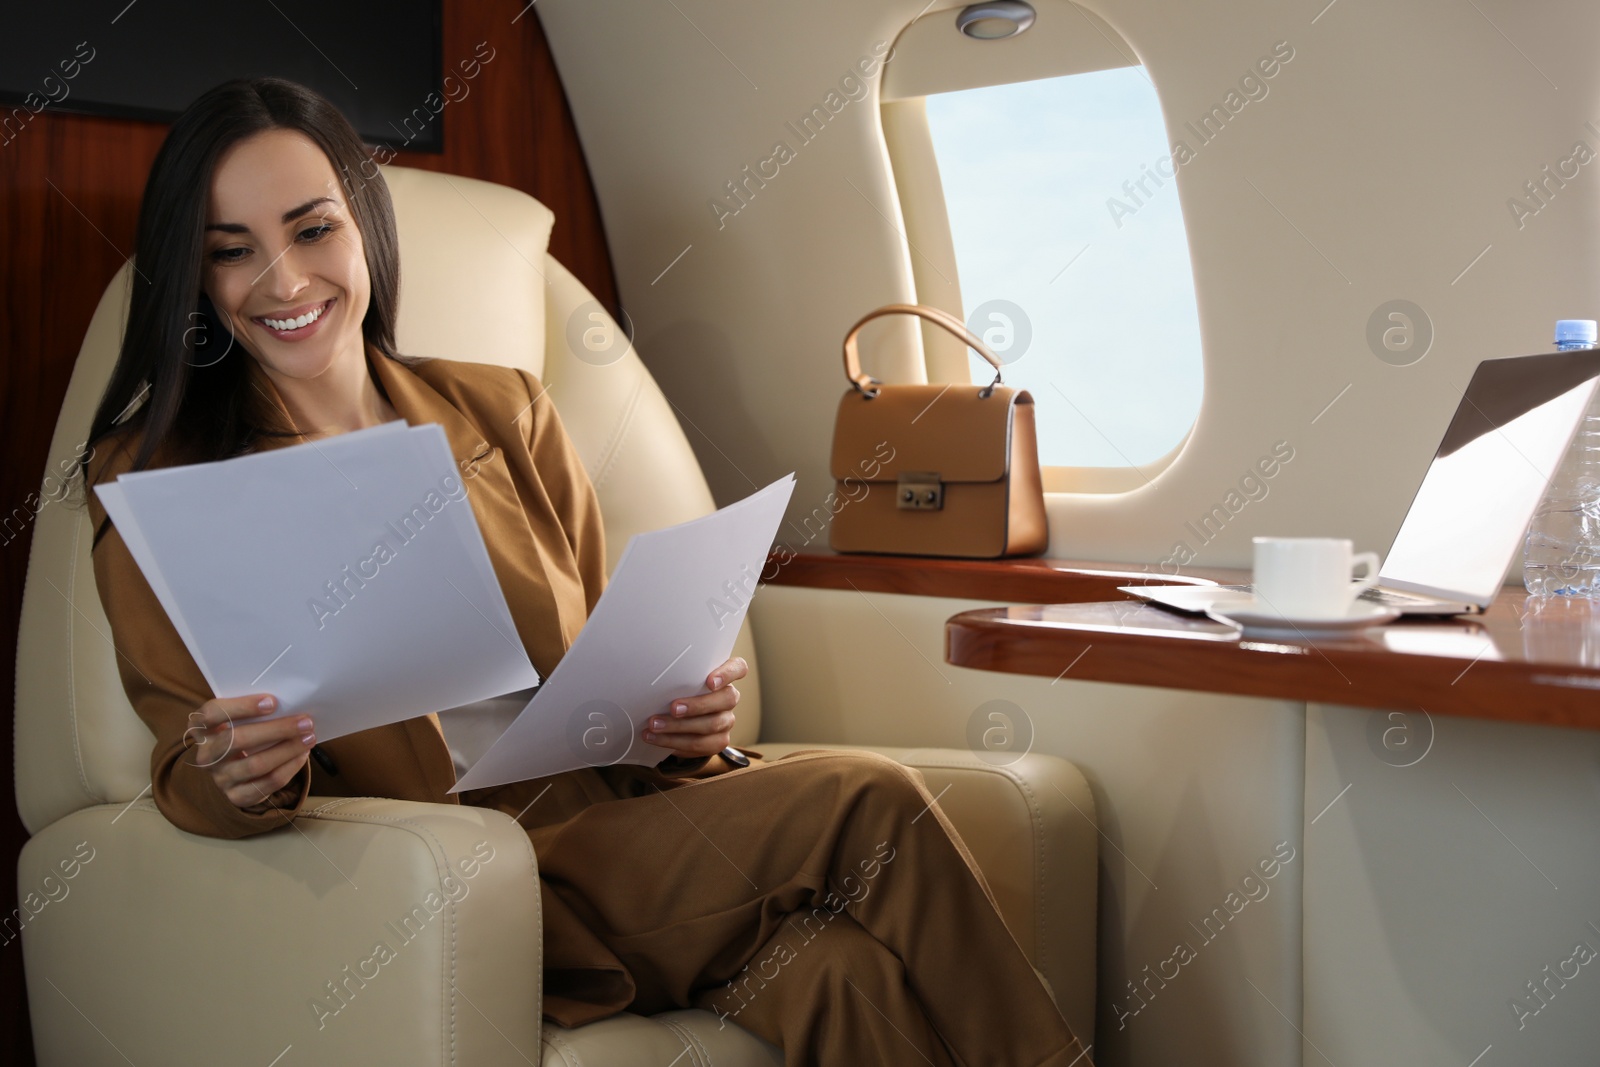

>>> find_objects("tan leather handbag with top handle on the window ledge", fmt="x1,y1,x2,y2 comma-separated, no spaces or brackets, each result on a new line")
829,304,1048,560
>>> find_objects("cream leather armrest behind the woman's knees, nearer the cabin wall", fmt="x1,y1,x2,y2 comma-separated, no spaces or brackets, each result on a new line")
752,741,1099,1046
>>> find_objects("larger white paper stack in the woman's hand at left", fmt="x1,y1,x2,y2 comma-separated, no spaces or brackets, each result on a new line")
96,421,539,741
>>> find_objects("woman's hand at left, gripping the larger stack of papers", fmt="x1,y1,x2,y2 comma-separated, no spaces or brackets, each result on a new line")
184,693,317,808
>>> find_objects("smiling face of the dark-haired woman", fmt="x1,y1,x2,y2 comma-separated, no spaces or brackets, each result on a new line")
202,130,371,379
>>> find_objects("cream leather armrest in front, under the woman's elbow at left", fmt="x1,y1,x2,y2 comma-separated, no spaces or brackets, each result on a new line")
20,797,542,1067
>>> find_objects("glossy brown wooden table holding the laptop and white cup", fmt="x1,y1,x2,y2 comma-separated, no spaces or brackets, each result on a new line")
946,589,1600,729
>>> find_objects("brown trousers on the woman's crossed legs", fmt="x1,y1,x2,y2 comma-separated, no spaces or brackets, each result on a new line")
469,750,1090,1067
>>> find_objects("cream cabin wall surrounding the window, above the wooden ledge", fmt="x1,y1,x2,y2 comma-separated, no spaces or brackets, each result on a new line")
539,0,1600,566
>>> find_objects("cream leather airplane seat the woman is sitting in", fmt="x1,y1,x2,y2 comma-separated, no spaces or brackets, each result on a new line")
8,168,1096,1067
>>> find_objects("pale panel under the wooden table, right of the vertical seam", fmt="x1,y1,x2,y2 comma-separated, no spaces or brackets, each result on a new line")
1301,705,1600,1067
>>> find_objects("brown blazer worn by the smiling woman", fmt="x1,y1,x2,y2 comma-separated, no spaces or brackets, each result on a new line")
90,357,588,838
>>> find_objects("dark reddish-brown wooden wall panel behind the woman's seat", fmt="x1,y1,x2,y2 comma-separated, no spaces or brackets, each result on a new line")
0,0,618,1064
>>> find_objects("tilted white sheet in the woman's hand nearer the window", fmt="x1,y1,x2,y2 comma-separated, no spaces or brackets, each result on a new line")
451,474,795,792
